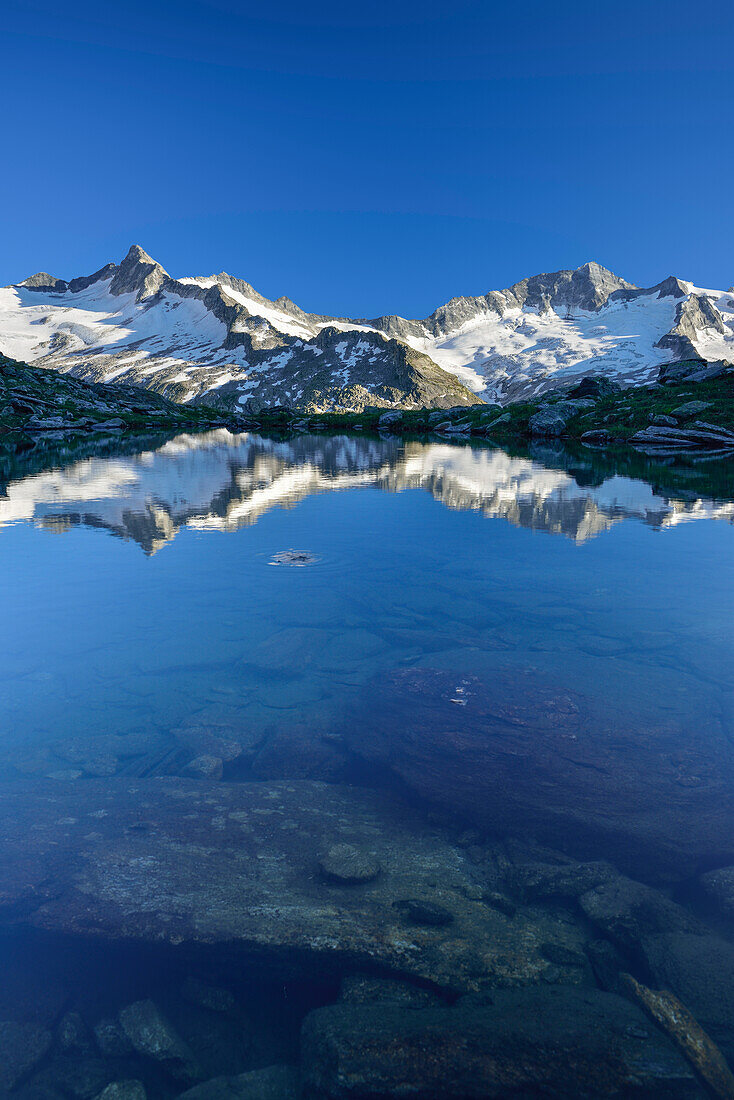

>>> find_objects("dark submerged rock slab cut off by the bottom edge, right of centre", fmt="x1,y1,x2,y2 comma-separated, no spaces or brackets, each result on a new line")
302,988,703,1100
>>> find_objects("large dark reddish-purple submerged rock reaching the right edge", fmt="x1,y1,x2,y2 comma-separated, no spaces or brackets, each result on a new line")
346,669,734,880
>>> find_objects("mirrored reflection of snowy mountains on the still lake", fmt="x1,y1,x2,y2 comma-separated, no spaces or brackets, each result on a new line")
0,429,734,553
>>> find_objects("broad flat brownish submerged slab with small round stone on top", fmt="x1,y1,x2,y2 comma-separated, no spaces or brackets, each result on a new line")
0,778,572,994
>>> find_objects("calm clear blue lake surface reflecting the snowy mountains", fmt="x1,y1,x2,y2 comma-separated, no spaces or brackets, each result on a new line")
0,430,734,1097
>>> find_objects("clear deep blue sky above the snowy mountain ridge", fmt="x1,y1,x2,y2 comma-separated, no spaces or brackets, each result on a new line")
0,0,734,316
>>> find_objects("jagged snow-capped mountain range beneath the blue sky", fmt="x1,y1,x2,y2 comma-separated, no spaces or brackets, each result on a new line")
0,245,734,411
